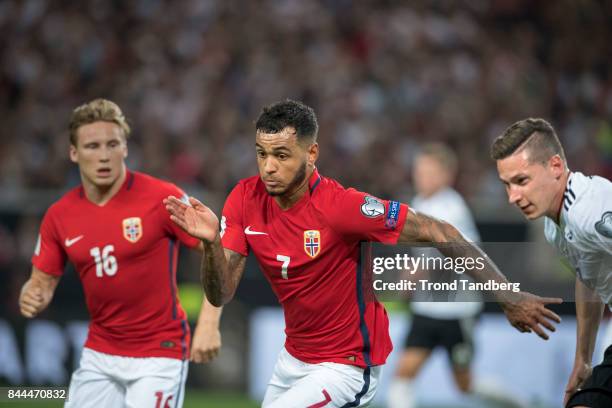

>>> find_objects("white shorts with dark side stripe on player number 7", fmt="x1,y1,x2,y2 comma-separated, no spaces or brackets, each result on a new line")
261,348,381,408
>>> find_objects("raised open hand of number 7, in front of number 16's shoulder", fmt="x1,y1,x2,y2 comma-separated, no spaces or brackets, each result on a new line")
164,196,219,242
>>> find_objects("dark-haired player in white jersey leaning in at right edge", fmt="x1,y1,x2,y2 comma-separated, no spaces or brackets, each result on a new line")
491,118,612,408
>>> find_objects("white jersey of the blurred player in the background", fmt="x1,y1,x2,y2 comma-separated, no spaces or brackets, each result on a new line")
411,188,482,319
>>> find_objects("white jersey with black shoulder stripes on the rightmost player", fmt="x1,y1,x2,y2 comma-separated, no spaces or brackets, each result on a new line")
544,172,612,304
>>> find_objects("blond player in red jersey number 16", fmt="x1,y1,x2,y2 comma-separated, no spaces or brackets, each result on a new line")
19,99,221,407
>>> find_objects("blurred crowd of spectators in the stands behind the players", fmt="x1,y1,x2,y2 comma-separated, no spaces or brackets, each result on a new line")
0,0,612,200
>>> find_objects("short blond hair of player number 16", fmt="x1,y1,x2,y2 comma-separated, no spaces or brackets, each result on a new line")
69,98,130,146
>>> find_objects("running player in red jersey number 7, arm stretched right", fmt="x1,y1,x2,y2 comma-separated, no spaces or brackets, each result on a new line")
164,100,560,408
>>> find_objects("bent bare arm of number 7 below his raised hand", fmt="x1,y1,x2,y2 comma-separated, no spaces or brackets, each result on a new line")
200,235,240,307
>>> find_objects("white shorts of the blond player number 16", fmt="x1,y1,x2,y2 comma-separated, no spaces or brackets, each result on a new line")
64,348,189,408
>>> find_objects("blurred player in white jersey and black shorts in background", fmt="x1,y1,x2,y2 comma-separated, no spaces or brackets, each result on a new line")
388,144,518,408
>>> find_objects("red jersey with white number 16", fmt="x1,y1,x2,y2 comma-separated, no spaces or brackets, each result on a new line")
32,172,199,359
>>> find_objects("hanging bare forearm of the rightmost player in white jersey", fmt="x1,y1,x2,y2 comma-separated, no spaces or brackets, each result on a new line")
575,279,604,364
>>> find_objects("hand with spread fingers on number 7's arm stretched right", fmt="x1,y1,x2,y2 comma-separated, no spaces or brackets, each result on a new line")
501,292,563,340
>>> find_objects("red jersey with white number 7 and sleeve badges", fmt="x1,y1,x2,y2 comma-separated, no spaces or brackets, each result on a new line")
221,170,408,367
